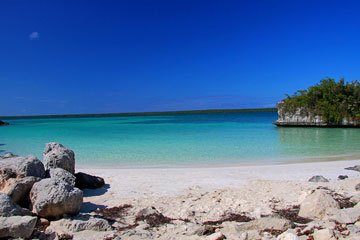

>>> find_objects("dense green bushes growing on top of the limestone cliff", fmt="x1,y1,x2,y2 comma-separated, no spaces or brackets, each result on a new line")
278,77,360,124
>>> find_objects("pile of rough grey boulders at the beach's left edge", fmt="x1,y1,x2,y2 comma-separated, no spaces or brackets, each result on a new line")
0,143,105,239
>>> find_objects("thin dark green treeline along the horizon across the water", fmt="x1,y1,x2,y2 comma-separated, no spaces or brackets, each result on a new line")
0,108,277,118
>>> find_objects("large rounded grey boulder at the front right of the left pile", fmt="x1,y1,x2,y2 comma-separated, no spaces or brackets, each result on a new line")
30,178,83,218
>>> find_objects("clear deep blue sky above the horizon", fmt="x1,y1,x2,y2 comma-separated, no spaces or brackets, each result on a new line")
0,0,360,115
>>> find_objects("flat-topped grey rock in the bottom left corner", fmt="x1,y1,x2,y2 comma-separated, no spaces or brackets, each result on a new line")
0,216,37,238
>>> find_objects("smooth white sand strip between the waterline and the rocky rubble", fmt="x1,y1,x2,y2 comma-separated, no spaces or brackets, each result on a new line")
77,160,360,205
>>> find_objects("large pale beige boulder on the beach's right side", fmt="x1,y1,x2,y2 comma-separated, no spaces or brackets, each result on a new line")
299,189,340,220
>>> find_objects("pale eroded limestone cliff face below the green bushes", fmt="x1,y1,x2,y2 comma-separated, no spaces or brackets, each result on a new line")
273,101,360,127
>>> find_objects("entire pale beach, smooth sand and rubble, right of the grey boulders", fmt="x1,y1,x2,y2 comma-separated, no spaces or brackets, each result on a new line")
67,160,360,240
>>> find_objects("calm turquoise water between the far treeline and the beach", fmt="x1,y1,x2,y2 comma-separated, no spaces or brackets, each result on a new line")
0,113,360,167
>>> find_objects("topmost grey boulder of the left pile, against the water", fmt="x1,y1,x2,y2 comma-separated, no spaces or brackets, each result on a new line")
44,142,75,174
